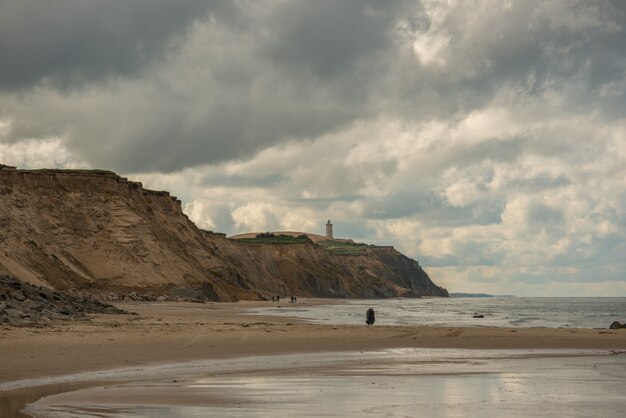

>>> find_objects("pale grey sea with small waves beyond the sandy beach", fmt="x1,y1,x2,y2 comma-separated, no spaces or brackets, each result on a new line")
251,297,626,328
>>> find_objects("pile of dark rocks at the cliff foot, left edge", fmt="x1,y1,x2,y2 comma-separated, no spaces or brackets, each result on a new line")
0,275,128,326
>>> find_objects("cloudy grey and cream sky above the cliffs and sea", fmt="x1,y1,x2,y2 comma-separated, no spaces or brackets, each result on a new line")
0,0,626,296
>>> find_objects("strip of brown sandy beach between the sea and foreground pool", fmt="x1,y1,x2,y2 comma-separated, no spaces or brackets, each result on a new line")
0,300,626,416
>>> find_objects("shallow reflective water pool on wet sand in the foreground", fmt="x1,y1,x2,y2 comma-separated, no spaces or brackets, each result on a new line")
18,350,626,417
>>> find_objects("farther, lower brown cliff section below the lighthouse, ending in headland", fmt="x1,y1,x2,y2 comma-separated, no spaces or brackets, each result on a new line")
219,243,447,298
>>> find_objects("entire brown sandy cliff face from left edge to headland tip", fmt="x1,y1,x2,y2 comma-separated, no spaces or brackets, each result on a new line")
0,166,446,300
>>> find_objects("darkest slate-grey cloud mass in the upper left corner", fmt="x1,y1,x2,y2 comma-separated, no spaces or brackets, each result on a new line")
0,0,215,90
